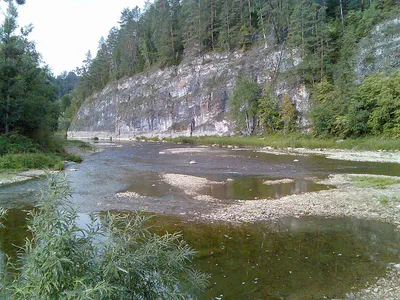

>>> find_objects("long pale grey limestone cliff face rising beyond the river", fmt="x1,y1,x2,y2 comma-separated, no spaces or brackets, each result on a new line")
68,47,309,139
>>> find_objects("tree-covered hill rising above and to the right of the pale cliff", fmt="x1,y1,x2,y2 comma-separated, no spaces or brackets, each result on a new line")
65,0,400,136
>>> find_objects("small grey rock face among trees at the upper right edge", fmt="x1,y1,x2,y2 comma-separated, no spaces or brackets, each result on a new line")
356,18,400,80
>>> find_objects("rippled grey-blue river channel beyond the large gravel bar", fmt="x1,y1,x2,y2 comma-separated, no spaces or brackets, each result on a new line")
63,142,400,214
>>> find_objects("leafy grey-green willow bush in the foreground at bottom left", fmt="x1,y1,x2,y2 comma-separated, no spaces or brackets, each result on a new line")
0,177,207,300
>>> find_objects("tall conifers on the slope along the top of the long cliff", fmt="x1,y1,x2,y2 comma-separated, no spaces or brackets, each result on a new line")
64,0,400,138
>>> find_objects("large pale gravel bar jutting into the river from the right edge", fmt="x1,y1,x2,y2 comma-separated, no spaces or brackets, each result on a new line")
202,174,400,226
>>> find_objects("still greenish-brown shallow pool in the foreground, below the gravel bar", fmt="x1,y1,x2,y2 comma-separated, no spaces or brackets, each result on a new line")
0,209,400,299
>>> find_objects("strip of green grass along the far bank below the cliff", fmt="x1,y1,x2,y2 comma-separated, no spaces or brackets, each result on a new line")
165,133,400,151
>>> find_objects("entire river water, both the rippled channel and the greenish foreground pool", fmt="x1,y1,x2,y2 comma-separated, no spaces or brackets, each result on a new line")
0,143,400,299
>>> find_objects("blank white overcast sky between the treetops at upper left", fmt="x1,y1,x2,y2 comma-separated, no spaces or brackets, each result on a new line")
1,0,145,75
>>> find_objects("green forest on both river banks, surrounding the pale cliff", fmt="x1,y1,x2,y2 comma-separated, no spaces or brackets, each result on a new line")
0,0,400,144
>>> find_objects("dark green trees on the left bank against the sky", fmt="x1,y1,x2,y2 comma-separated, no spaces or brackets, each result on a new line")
0,1,58,138
